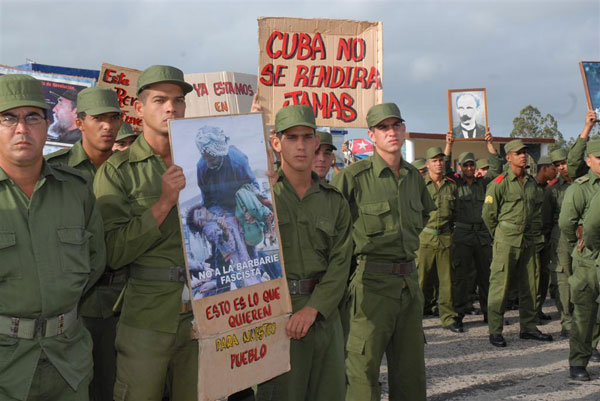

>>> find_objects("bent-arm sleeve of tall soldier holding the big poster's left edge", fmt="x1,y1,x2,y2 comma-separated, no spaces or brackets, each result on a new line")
94,162,161,269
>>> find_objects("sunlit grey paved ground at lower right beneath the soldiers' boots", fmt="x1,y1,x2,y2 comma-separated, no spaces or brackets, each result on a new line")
381,299,600,401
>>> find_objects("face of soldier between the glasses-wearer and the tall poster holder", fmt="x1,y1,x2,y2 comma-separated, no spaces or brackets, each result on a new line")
77,113,123,152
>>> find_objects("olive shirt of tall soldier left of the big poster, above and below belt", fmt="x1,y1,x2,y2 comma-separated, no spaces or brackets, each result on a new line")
94,136,184,333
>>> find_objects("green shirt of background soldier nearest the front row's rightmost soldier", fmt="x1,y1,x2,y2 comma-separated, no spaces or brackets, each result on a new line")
420,174,457,248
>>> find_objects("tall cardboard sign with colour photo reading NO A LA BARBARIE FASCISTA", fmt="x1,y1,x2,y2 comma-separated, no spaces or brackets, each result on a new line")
169,113,291,400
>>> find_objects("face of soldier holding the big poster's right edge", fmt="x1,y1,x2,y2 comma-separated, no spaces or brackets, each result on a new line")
271,125,319,172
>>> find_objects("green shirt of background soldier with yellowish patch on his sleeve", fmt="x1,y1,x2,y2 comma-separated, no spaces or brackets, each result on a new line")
482,167,544,248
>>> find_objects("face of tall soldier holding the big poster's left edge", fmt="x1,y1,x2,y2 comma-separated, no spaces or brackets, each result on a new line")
135,82,185,136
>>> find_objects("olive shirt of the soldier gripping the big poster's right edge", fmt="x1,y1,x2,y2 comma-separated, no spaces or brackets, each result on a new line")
273,170,352,319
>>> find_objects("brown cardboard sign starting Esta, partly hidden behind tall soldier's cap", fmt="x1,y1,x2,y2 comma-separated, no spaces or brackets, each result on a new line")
98,63,142,133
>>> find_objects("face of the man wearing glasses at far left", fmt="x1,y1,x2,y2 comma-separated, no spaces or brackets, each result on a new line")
0,106,48,167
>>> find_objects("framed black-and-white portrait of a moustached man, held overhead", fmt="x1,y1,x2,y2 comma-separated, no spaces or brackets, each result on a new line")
448,88,488,139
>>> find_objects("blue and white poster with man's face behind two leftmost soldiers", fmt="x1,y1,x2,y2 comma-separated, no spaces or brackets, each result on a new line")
0,65,96,147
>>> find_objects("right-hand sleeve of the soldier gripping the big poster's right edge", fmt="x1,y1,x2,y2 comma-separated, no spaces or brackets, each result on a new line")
307,195,353,319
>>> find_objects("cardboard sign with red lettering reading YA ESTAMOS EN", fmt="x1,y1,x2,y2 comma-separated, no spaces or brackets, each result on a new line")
185,71,257,117
